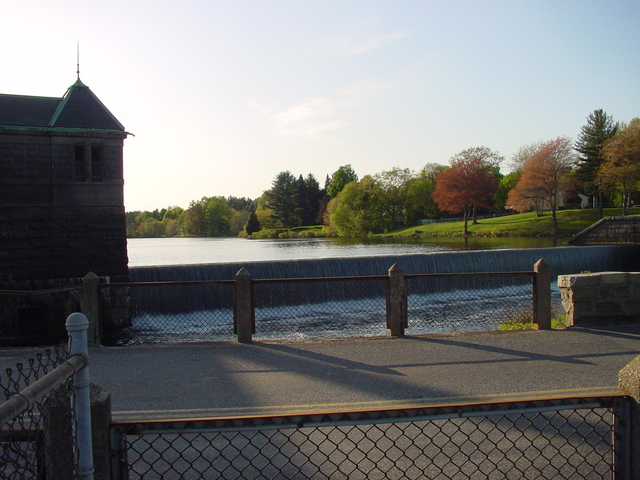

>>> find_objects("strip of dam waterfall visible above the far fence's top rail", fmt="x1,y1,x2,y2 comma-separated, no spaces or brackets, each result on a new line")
130,246,640,282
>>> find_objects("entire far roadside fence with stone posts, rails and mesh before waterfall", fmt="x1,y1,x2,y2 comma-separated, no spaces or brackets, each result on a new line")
0,261,551,346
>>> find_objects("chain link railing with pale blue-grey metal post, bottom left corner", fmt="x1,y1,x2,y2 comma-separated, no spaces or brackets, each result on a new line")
0,313,93,480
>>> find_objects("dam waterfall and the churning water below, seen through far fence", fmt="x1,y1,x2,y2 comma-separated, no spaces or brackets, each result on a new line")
115,246,640,344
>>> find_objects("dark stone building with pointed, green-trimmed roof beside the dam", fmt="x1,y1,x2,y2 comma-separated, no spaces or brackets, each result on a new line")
0,78,129,290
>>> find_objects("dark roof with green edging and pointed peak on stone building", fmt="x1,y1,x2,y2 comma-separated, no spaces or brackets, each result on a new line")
0,79,124,132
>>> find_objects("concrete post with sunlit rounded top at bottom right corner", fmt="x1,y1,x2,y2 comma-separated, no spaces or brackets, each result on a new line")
614,357,640,479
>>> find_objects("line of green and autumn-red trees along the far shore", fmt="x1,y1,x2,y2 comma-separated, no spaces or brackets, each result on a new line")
126,109,640,237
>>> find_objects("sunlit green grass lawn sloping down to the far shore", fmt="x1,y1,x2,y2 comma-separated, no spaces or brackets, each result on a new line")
391,207,640,237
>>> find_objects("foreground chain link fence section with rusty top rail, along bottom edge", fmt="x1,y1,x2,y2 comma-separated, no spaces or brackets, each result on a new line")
112,396,629,479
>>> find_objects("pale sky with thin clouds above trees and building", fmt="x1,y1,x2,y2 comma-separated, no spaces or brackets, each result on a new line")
0,0,640,211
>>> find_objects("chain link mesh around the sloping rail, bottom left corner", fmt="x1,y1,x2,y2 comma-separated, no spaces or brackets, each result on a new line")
0,347,77,480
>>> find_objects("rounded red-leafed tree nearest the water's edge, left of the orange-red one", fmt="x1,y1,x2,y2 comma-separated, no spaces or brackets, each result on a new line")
432,147,502,237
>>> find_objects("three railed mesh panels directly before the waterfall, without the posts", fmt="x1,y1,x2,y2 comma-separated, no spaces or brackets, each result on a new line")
100,271,537,345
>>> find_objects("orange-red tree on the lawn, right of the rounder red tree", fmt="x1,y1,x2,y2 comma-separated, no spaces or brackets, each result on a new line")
507,137,577,236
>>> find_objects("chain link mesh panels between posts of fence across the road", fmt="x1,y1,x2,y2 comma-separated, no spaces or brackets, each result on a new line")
0,272,552,346
